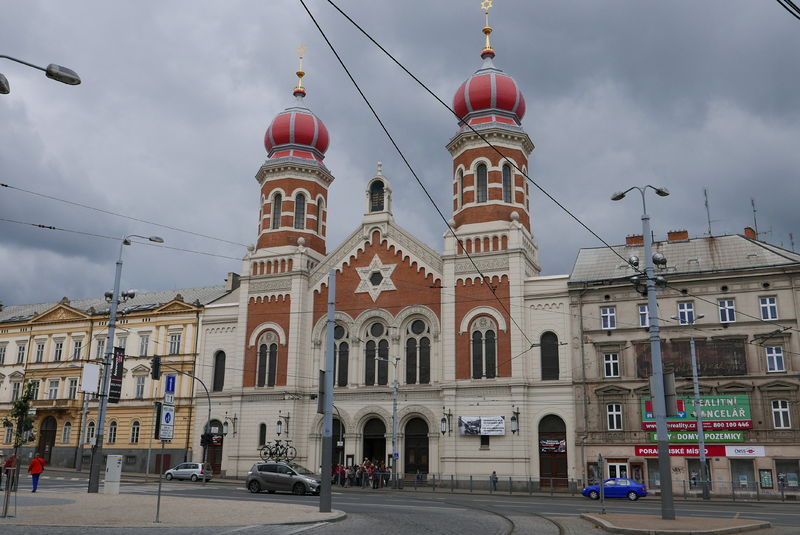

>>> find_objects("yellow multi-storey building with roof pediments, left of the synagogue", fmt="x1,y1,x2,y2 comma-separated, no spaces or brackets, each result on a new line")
0,286,226,472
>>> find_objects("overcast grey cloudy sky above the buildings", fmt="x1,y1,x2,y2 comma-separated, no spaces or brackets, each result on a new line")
0,0,800,305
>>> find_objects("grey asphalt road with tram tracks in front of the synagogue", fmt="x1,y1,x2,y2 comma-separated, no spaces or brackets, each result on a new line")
3,470,800,535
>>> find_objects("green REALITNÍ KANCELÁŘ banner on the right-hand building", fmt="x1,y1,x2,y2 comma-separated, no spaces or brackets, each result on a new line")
642,394,753,431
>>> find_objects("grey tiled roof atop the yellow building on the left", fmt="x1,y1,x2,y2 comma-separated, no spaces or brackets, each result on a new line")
0,286,225,323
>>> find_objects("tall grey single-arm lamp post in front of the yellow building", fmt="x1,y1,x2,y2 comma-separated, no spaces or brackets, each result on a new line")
88,234,164,493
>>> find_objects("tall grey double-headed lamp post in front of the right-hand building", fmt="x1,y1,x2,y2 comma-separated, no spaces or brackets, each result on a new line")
611,184,675,520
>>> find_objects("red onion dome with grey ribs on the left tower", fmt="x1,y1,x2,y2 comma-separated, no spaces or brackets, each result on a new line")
264,93,330,161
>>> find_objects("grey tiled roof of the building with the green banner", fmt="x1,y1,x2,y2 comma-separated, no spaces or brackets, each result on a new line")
569,234,800,283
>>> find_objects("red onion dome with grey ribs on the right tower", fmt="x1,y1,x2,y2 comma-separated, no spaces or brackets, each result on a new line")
453,56,525,125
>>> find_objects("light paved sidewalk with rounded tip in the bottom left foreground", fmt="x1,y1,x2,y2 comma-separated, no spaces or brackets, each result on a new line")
0,489,346,527
